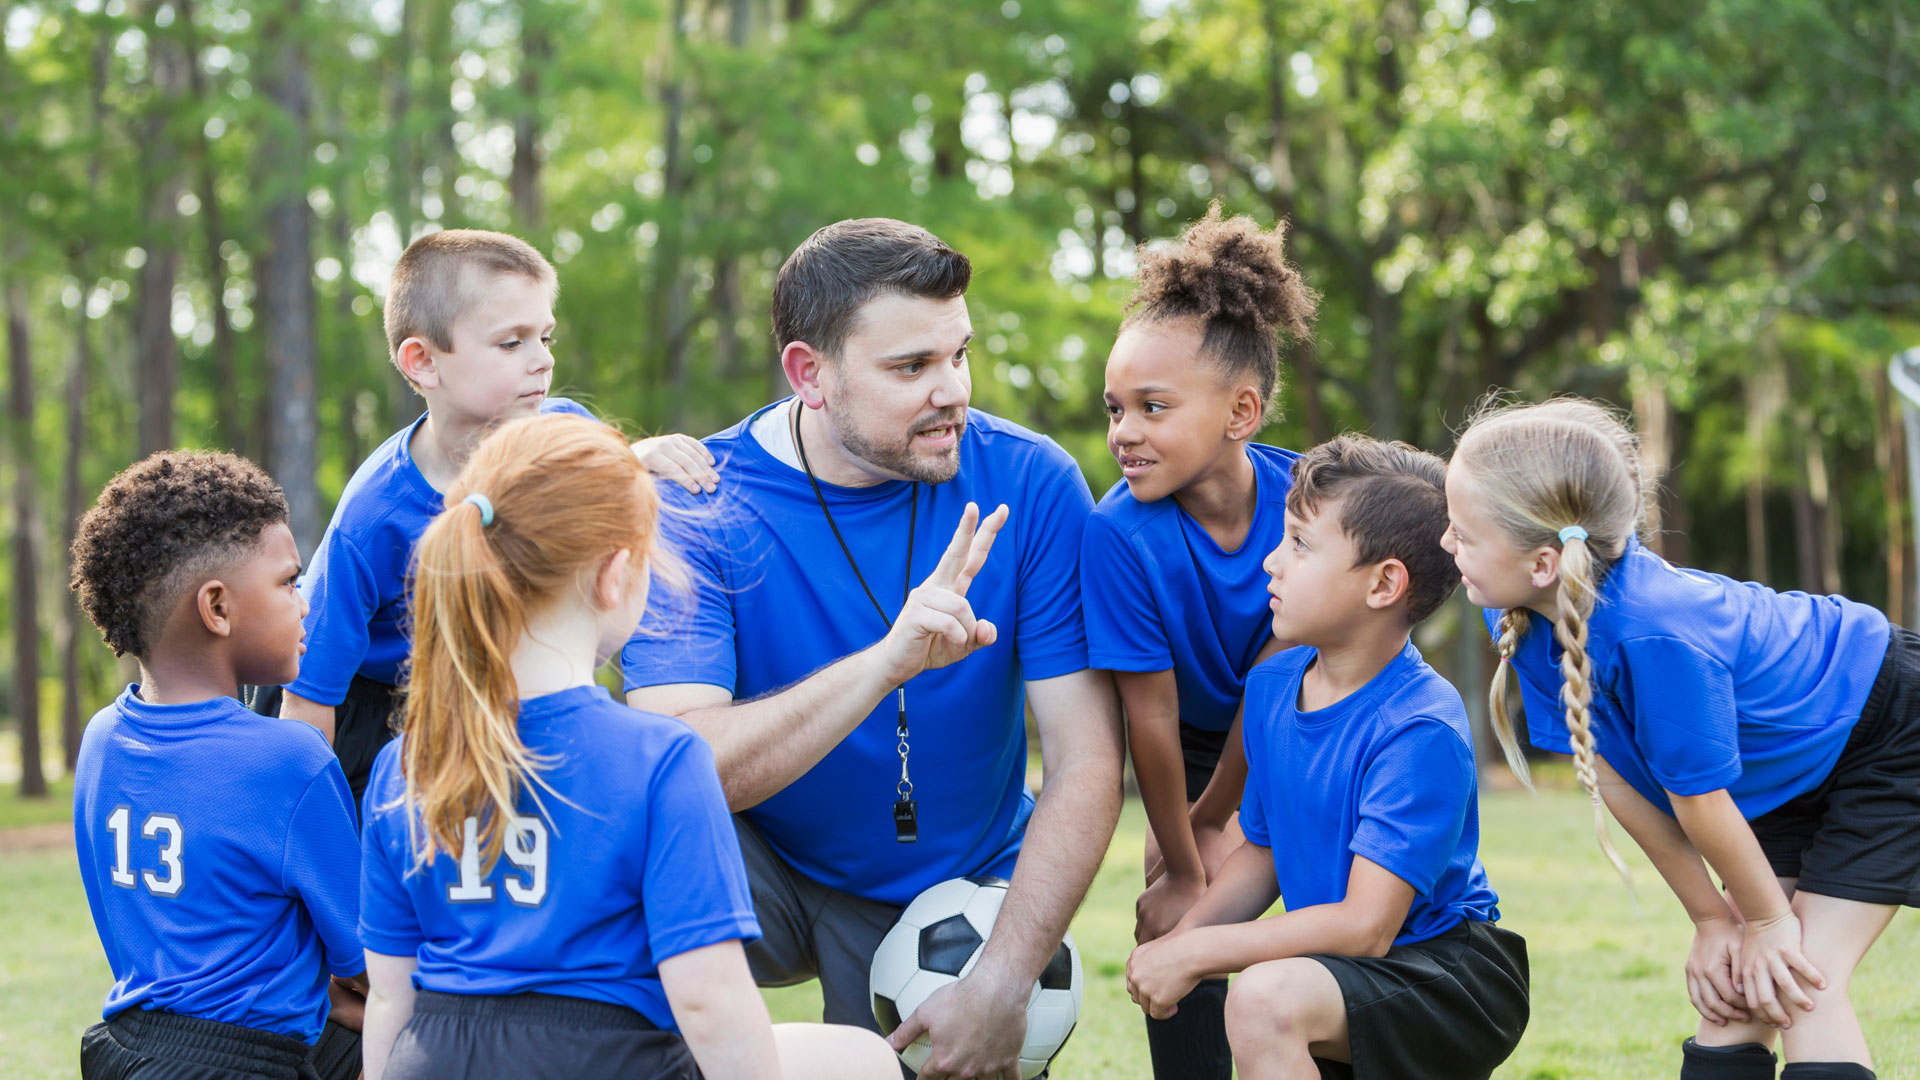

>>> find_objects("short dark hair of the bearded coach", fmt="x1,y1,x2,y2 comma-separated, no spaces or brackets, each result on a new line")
774,217,973,359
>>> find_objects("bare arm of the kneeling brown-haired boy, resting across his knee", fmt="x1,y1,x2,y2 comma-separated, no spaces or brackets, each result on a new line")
1127,844,1415,1020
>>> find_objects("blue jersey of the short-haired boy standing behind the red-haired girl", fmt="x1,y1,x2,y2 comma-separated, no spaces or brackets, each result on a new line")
286,398,593,705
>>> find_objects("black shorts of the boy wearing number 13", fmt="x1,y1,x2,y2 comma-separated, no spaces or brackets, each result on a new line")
81,1009,359,1080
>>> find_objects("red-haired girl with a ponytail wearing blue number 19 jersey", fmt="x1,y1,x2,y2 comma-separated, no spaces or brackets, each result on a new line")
359,415,899,1080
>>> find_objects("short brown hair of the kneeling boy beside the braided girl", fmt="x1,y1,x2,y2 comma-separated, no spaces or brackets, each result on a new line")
1286,434,1459,625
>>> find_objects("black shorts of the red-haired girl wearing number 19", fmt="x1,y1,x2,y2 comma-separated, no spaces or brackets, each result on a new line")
386,990,701,1080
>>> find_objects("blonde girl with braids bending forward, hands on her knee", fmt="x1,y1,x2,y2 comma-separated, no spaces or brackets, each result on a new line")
1444,398,1920,1080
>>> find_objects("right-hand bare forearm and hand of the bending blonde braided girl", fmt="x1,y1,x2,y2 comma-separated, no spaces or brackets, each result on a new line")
1667,788,1826,1028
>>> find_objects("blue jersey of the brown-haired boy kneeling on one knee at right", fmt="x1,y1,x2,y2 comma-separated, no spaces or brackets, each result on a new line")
1240,642,1500,945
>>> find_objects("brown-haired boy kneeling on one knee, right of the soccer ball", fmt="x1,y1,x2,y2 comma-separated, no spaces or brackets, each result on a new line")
1127,436,1528,1080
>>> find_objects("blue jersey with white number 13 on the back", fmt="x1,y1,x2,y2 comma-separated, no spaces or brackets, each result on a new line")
73,686,367,1043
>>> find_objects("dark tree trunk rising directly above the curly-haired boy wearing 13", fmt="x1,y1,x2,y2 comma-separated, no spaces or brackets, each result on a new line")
134,13,192,457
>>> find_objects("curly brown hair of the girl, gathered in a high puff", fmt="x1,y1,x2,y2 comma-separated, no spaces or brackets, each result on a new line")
1121,200,1319,417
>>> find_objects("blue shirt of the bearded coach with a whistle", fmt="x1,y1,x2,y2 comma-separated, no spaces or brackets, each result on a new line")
620,402,1092,903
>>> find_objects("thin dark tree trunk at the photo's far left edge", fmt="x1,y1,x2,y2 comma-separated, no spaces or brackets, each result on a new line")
6,272,46,798
